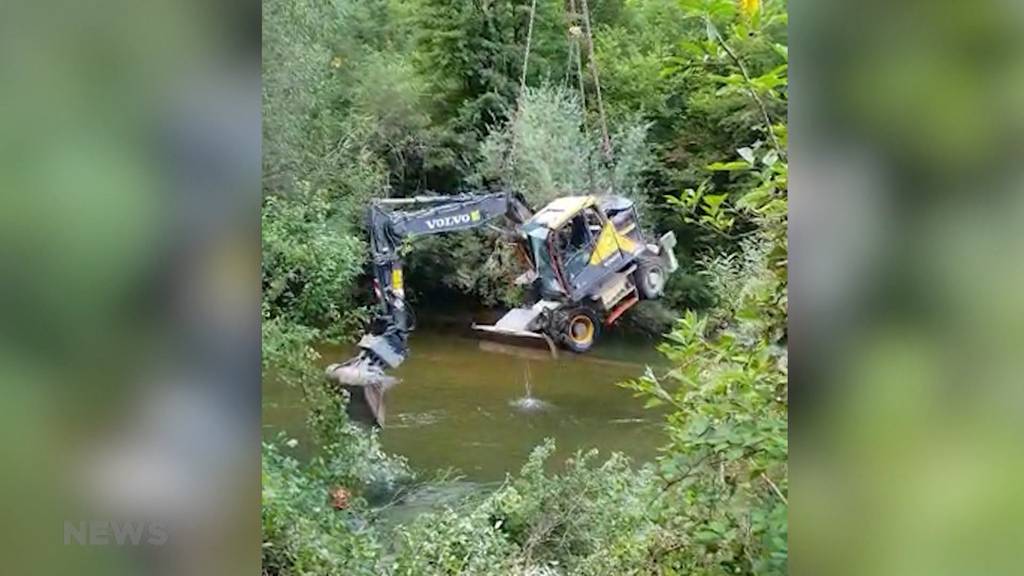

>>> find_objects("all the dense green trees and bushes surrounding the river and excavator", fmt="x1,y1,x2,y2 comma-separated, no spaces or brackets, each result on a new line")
262,0,788,575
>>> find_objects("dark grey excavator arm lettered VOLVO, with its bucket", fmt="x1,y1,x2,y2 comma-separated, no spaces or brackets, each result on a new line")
327,193,532,424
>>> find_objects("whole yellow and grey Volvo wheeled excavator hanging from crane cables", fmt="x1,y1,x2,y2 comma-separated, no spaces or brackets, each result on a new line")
327,192,678,425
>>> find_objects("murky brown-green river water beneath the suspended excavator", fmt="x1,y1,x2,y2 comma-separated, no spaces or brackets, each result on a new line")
263,328,665,482
